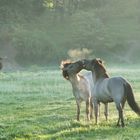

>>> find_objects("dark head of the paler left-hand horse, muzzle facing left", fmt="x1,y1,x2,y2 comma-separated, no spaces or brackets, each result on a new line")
60,61,83,80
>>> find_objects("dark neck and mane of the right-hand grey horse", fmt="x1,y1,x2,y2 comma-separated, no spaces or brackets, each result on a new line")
94,60,109,79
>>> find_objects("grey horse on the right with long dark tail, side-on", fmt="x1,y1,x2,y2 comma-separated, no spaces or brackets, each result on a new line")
81,59,140,127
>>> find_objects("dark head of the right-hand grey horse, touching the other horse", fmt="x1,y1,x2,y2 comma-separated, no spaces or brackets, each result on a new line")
81,58,103,71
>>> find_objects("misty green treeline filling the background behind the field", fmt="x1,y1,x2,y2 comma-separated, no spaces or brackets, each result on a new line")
0,0,140,65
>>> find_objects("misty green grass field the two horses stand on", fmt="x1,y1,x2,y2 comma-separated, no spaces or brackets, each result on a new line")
0,67,140,140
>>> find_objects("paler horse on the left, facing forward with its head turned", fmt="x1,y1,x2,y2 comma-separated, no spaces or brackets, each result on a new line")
60,61,93,121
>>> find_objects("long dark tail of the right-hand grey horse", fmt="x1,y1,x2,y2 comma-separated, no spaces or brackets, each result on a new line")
125,83,140,116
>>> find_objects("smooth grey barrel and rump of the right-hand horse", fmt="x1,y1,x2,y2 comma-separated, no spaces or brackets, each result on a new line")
94,77,127,103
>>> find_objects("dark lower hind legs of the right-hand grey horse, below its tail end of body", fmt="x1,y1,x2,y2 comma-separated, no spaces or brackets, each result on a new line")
116,103,124,127
